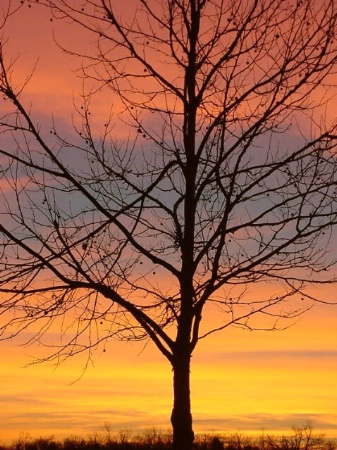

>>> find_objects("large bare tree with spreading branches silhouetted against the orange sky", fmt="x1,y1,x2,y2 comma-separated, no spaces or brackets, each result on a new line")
0,0,337,450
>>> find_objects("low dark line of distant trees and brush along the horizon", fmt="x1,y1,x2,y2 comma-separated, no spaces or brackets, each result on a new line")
0,425,337,450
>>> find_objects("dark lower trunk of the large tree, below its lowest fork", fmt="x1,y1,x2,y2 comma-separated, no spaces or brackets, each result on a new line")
171,354,194,450
